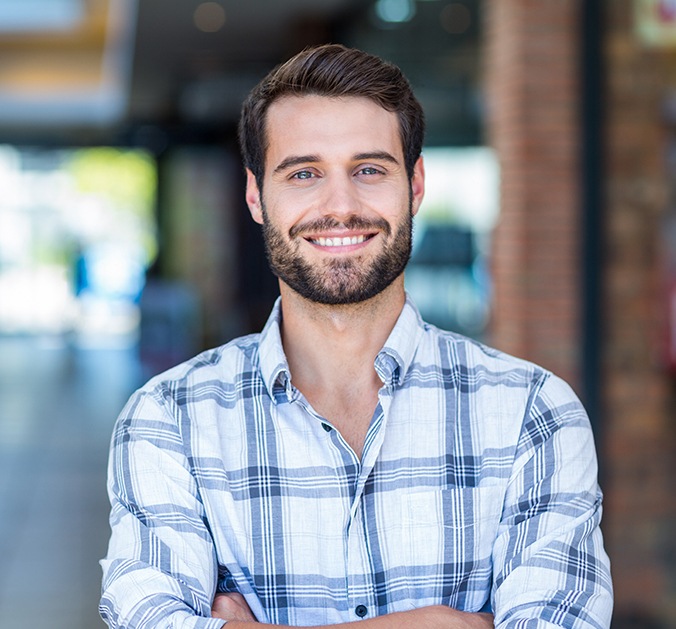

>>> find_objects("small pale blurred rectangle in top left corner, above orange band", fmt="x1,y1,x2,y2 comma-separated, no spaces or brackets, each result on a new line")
0,0,84,33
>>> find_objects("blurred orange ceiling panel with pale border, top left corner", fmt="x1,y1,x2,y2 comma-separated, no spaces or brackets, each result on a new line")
0,0,138,128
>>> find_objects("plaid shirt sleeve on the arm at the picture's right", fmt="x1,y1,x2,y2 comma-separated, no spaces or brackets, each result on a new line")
492,374,613,629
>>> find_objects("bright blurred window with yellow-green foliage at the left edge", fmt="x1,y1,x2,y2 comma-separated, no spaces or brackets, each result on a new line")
0,146,157,338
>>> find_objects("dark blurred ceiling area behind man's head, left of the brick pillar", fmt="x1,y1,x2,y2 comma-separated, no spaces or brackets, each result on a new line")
0,0,481,148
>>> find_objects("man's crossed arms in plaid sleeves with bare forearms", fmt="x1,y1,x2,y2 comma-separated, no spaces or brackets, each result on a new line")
101,368,612,629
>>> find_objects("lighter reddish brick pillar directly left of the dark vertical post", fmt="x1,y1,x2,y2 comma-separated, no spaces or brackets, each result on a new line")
484,0,580,388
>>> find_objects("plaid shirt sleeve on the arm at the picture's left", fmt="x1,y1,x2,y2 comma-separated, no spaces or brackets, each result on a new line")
99,386,224,629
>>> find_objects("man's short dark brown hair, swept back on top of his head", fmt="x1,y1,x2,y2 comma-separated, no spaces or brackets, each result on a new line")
239,44,425,189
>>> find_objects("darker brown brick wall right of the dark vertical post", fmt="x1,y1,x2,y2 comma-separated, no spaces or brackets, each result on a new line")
602,0,676,627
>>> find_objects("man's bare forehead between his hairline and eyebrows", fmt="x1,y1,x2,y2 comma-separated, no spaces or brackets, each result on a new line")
266,95,403,162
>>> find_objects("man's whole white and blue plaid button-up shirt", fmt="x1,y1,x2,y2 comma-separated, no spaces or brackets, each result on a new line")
100,301,612,629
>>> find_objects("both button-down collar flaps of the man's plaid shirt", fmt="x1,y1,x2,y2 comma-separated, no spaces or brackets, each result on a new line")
259,294,424,401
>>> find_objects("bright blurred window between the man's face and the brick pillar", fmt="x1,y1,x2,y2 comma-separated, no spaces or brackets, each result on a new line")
406,148,498,338
